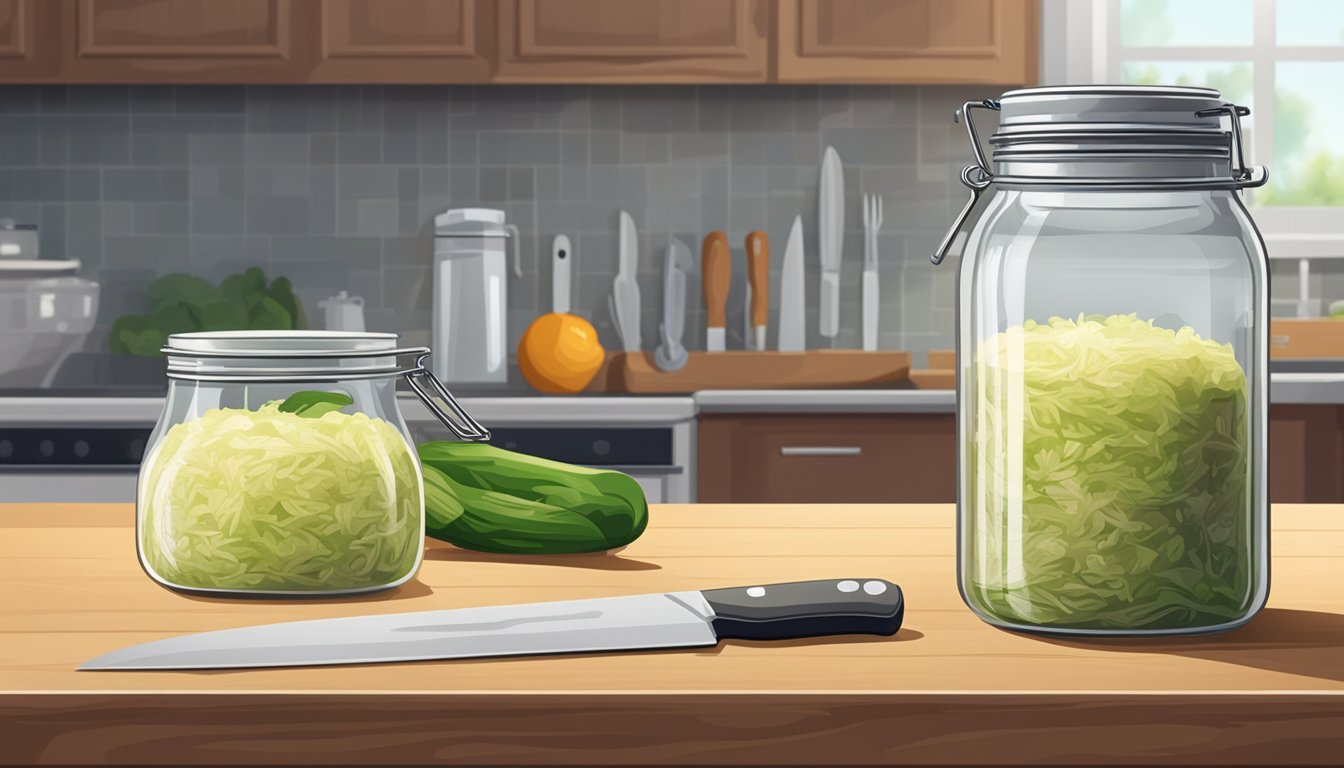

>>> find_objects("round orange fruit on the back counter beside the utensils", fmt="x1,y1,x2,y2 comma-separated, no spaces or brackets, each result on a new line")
517,312,606,394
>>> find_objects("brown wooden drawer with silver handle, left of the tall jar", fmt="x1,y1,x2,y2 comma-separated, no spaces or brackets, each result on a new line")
696,413,957,503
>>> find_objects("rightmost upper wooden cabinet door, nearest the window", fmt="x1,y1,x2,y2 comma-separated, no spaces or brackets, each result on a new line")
775,0,1038,85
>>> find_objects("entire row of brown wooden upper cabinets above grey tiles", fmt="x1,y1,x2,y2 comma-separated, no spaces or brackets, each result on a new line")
0,0,1038,85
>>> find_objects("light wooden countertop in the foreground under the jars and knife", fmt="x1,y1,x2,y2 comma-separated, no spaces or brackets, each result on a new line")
0,504,1344,765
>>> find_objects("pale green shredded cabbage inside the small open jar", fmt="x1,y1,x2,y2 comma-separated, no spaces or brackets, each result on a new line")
140,404,425,592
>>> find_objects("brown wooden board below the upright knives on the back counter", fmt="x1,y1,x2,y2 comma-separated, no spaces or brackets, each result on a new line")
589,350,910,394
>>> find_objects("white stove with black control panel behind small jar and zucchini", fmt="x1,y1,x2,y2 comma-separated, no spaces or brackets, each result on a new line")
0,390,696,503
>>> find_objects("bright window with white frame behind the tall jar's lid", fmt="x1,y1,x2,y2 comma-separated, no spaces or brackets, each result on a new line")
1043,0,1344,242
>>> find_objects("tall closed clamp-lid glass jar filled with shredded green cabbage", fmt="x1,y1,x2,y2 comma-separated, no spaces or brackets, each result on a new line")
934,86,1269,635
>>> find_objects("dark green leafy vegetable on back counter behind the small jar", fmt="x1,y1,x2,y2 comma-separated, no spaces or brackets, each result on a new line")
109,266,305,356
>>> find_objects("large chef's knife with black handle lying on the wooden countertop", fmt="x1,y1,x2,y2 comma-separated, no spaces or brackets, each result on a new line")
79,578,905,670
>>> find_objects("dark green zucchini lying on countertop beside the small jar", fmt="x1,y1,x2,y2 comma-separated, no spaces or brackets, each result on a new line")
419,441,649,554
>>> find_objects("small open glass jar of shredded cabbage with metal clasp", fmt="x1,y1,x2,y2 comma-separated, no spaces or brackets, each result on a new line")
136,331,489,597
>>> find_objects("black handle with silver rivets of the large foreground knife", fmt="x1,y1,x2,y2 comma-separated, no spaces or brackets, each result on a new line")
702,578,906,640
